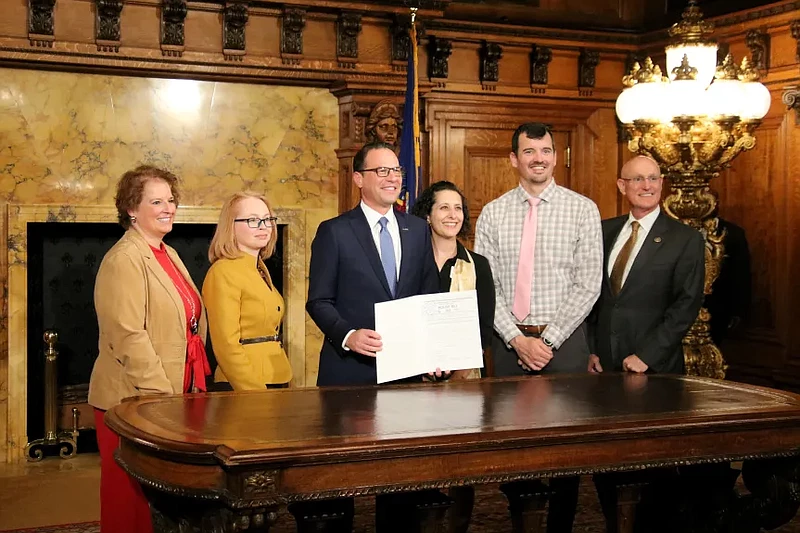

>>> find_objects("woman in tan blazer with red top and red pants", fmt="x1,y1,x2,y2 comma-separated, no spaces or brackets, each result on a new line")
89,166,211,533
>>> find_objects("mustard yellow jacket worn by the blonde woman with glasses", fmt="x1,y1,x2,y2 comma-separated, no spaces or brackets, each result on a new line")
203,254,292,390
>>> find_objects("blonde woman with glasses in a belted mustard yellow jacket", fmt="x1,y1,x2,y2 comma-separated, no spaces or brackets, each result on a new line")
203,192,292,391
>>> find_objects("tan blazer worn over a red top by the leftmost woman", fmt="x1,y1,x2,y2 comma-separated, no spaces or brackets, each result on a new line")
89,229,206,409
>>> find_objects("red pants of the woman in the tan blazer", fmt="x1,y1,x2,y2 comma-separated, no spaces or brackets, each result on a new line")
94,409,153,533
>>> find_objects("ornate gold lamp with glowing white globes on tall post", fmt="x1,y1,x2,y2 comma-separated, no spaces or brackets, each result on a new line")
616,0,771,378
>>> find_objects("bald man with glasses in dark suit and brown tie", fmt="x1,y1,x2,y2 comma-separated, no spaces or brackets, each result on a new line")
589,156,705,374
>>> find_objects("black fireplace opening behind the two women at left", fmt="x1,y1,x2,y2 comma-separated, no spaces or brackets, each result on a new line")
27,222,286,453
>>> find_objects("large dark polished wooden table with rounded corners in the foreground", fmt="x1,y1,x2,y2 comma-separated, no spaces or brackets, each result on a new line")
106,374,800,532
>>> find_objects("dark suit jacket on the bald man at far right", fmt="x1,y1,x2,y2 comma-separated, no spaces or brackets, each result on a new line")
588,211,705,373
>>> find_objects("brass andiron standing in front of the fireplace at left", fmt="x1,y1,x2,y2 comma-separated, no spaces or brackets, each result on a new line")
25,330,78,461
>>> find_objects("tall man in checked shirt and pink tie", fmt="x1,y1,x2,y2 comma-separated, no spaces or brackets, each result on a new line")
475,123,603,533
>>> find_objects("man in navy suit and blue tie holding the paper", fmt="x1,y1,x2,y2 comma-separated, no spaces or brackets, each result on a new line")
306,139,439,386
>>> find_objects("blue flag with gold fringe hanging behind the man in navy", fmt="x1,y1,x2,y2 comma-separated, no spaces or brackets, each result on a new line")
398,19,422,212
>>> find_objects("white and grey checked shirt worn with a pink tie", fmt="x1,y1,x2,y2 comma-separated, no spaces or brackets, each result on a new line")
475,181,603,348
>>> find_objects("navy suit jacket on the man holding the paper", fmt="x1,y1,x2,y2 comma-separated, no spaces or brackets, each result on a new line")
306,206,439,386
